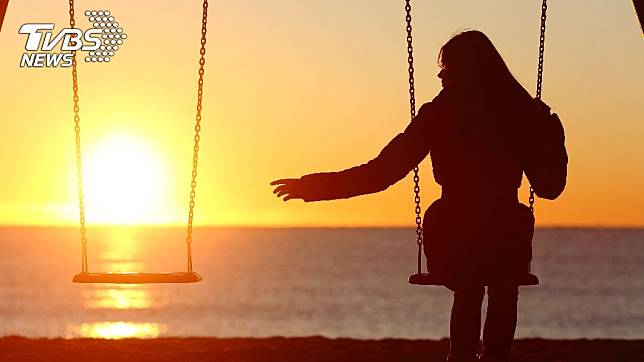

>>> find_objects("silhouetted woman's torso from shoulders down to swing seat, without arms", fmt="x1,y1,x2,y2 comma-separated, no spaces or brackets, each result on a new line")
419,88,537,286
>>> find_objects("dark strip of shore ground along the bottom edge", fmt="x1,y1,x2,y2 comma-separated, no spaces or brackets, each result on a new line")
0,337,644,362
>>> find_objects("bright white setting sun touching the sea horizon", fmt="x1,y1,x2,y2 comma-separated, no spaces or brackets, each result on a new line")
83,134,176,224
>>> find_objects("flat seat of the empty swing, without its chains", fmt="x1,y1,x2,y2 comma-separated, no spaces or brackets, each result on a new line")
72,272,201,284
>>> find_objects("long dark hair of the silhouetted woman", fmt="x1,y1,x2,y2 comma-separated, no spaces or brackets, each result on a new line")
438,30,532,106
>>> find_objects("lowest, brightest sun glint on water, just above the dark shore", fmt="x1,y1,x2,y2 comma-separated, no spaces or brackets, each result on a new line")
67,321,166,339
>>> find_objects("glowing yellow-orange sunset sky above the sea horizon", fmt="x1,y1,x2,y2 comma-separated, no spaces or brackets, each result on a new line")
0,0,644,226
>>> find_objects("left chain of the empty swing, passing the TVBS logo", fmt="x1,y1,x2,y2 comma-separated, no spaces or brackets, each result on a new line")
69,0,87,273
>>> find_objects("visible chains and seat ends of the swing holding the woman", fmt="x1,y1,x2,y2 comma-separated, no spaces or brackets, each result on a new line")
405,0,547,285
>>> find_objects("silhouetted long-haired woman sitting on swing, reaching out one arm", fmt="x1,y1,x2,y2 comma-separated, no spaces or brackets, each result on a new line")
271,31,561,361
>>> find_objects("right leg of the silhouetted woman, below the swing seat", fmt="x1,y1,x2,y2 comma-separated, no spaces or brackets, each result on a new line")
481,286,519,362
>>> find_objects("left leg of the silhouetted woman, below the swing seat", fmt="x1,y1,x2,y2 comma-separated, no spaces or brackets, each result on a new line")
447,287,485,362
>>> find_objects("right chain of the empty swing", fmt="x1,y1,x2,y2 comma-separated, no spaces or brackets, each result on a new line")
186,0,208,272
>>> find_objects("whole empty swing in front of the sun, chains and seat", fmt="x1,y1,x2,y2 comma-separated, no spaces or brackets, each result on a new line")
69,0,208,284
